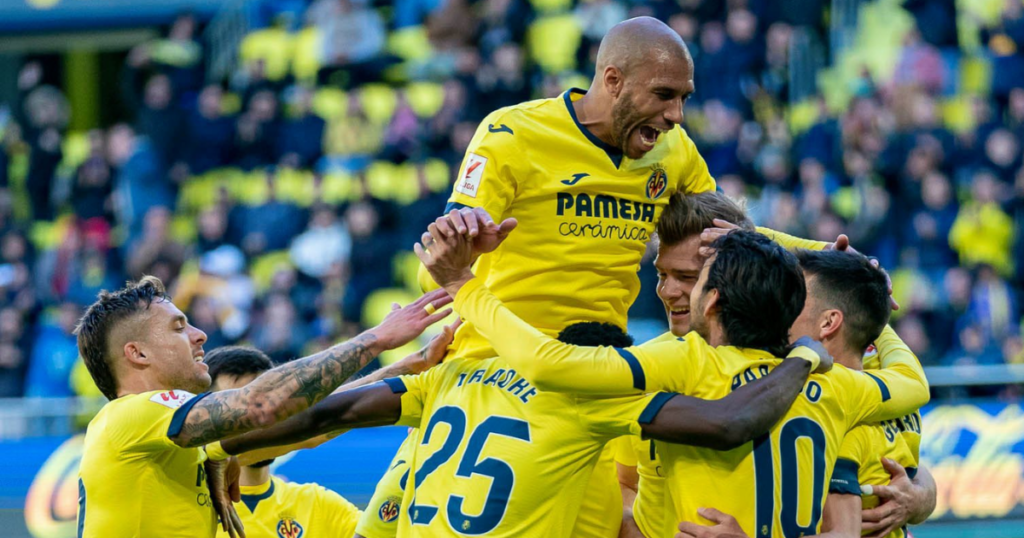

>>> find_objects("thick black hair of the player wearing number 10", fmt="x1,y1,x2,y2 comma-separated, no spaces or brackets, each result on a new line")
703,230,807,357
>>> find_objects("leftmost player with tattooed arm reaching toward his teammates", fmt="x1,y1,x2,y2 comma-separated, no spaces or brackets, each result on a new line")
77,277,451,538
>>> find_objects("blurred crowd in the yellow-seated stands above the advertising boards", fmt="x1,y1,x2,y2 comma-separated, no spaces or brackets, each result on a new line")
0,0,1024,399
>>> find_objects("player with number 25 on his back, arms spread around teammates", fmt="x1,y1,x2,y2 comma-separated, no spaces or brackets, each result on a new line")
193,311,820,538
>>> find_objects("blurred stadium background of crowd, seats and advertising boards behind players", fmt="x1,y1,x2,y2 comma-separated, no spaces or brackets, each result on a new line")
0,0,1024,538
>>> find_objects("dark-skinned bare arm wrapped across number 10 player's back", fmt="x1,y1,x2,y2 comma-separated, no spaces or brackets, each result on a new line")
640,359,811,450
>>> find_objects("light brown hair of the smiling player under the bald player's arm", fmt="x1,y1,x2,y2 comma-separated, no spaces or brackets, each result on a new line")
657,191,754,246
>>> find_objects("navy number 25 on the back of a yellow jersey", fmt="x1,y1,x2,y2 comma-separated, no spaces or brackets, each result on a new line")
400,406,529,535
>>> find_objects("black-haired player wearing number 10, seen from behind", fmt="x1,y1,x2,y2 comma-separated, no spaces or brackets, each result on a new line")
416,223,929,538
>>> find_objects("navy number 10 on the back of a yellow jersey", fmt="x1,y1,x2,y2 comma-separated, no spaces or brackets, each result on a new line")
754,417,825,538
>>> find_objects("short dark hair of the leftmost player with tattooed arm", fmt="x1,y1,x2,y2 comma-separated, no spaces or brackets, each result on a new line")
75,276,170,400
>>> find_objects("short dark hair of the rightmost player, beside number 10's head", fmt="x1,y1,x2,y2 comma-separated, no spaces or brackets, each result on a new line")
797,250,892,353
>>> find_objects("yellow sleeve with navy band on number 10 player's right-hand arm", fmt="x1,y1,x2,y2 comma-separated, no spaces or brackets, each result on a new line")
844,326,930,423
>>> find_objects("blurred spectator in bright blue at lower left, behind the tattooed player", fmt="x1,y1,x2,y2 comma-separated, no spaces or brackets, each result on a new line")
25,302,81,398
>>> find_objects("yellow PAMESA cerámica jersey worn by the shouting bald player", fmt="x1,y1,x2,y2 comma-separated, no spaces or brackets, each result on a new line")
421,89,715,358
